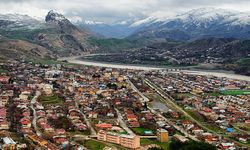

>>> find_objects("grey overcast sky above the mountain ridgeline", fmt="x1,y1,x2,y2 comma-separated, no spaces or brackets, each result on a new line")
0,0,250,23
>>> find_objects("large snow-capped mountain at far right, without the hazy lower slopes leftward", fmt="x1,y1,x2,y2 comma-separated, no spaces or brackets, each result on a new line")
131,8,250,40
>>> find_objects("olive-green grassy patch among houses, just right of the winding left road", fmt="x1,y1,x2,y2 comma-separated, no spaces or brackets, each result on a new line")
39,95,63,105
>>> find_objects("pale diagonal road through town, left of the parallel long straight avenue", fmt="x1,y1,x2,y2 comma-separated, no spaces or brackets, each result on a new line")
126,77,199,141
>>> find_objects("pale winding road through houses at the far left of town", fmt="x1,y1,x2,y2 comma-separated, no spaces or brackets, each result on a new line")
30,91,42,136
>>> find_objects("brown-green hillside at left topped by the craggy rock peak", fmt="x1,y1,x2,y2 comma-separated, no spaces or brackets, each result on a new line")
0,11,92,57
